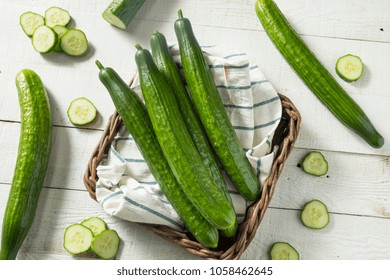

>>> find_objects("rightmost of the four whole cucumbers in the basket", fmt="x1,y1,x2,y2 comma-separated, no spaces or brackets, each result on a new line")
175,10,260,200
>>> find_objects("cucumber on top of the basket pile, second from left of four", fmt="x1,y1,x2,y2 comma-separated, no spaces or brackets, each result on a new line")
135,45,236,229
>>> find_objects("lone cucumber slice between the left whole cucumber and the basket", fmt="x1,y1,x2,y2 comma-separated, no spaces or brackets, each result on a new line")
68,97,97,125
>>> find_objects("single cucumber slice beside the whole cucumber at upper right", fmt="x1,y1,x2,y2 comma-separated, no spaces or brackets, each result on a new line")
336,54,364,83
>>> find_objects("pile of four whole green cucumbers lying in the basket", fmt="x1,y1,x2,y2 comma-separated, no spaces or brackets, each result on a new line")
96,10,260,248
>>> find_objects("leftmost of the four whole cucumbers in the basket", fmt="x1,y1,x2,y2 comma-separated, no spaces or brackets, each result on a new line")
96,61,219,248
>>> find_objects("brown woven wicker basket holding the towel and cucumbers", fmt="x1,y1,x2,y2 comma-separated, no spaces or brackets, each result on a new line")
83,94,301,260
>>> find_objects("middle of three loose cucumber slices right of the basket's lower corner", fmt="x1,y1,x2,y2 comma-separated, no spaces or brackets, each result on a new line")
301,199,330,229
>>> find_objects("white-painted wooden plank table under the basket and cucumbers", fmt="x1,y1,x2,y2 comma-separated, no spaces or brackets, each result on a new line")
0,0,390,259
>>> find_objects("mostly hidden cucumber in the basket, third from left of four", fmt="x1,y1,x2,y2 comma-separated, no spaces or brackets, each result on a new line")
150,32,238,237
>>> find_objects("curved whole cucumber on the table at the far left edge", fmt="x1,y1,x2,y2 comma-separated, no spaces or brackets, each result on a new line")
0,69,52,260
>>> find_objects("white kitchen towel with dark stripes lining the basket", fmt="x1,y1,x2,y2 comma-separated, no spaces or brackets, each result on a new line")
96,45,282,229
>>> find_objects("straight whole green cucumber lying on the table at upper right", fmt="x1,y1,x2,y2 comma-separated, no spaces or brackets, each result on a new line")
255,0,384,148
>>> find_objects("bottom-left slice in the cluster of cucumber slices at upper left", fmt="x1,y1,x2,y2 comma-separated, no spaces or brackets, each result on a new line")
31,25,58,53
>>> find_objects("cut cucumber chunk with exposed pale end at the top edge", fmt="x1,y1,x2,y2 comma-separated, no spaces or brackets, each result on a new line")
102,0,145,29
